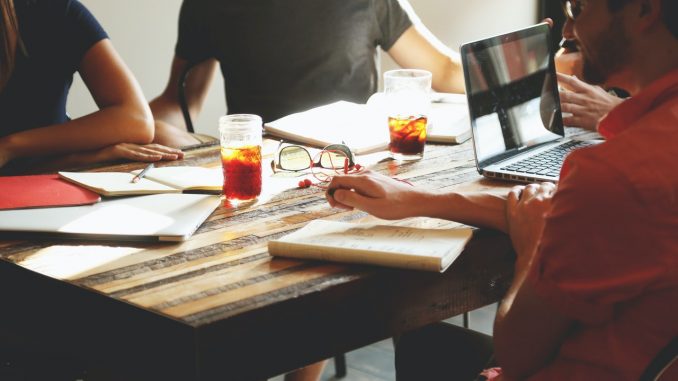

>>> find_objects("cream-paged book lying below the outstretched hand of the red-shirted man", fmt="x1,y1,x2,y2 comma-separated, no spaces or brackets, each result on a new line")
268,220,473,272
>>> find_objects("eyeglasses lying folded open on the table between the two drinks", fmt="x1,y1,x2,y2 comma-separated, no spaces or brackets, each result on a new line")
271,141,355,172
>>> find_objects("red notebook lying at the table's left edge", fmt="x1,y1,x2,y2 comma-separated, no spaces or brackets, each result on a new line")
0,174,101,210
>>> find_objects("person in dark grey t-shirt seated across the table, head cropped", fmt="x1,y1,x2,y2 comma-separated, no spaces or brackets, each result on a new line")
151,0,464,146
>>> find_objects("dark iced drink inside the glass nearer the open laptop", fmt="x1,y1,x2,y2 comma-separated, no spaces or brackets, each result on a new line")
388,116,427,158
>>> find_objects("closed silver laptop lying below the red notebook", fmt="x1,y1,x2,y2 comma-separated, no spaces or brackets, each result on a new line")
0,193,221,241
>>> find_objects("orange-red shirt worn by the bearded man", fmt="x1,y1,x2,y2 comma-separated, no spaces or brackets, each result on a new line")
529,70,678,381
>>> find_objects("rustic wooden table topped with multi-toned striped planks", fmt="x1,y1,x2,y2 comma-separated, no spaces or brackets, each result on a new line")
0,142,513,380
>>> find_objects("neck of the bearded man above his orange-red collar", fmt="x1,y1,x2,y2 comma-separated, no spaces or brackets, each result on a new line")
610,31,678,95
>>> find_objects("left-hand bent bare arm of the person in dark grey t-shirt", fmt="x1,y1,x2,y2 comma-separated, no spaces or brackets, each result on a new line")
150,57,218,147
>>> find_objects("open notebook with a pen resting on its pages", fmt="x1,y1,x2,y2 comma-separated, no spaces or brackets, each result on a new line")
59,166,224,196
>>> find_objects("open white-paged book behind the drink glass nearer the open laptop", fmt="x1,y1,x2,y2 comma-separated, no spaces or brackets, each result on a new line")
264,93,471,155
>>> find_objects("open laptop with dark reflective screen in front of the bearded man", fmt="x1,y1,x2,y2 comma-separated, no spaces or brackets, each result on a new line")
461,23,599,182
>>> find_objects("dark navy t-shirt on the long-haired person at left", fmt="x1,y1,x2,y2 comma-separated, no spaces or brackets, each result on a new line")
0,0,108,136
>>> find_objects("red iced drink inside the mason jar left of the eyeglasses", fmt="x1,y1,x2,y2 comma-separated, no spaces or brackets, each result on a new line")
221,145,261,200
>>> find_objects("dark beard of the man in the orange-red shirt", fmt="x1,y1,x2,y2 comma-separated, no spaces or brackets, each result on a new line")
582,18,628,85
